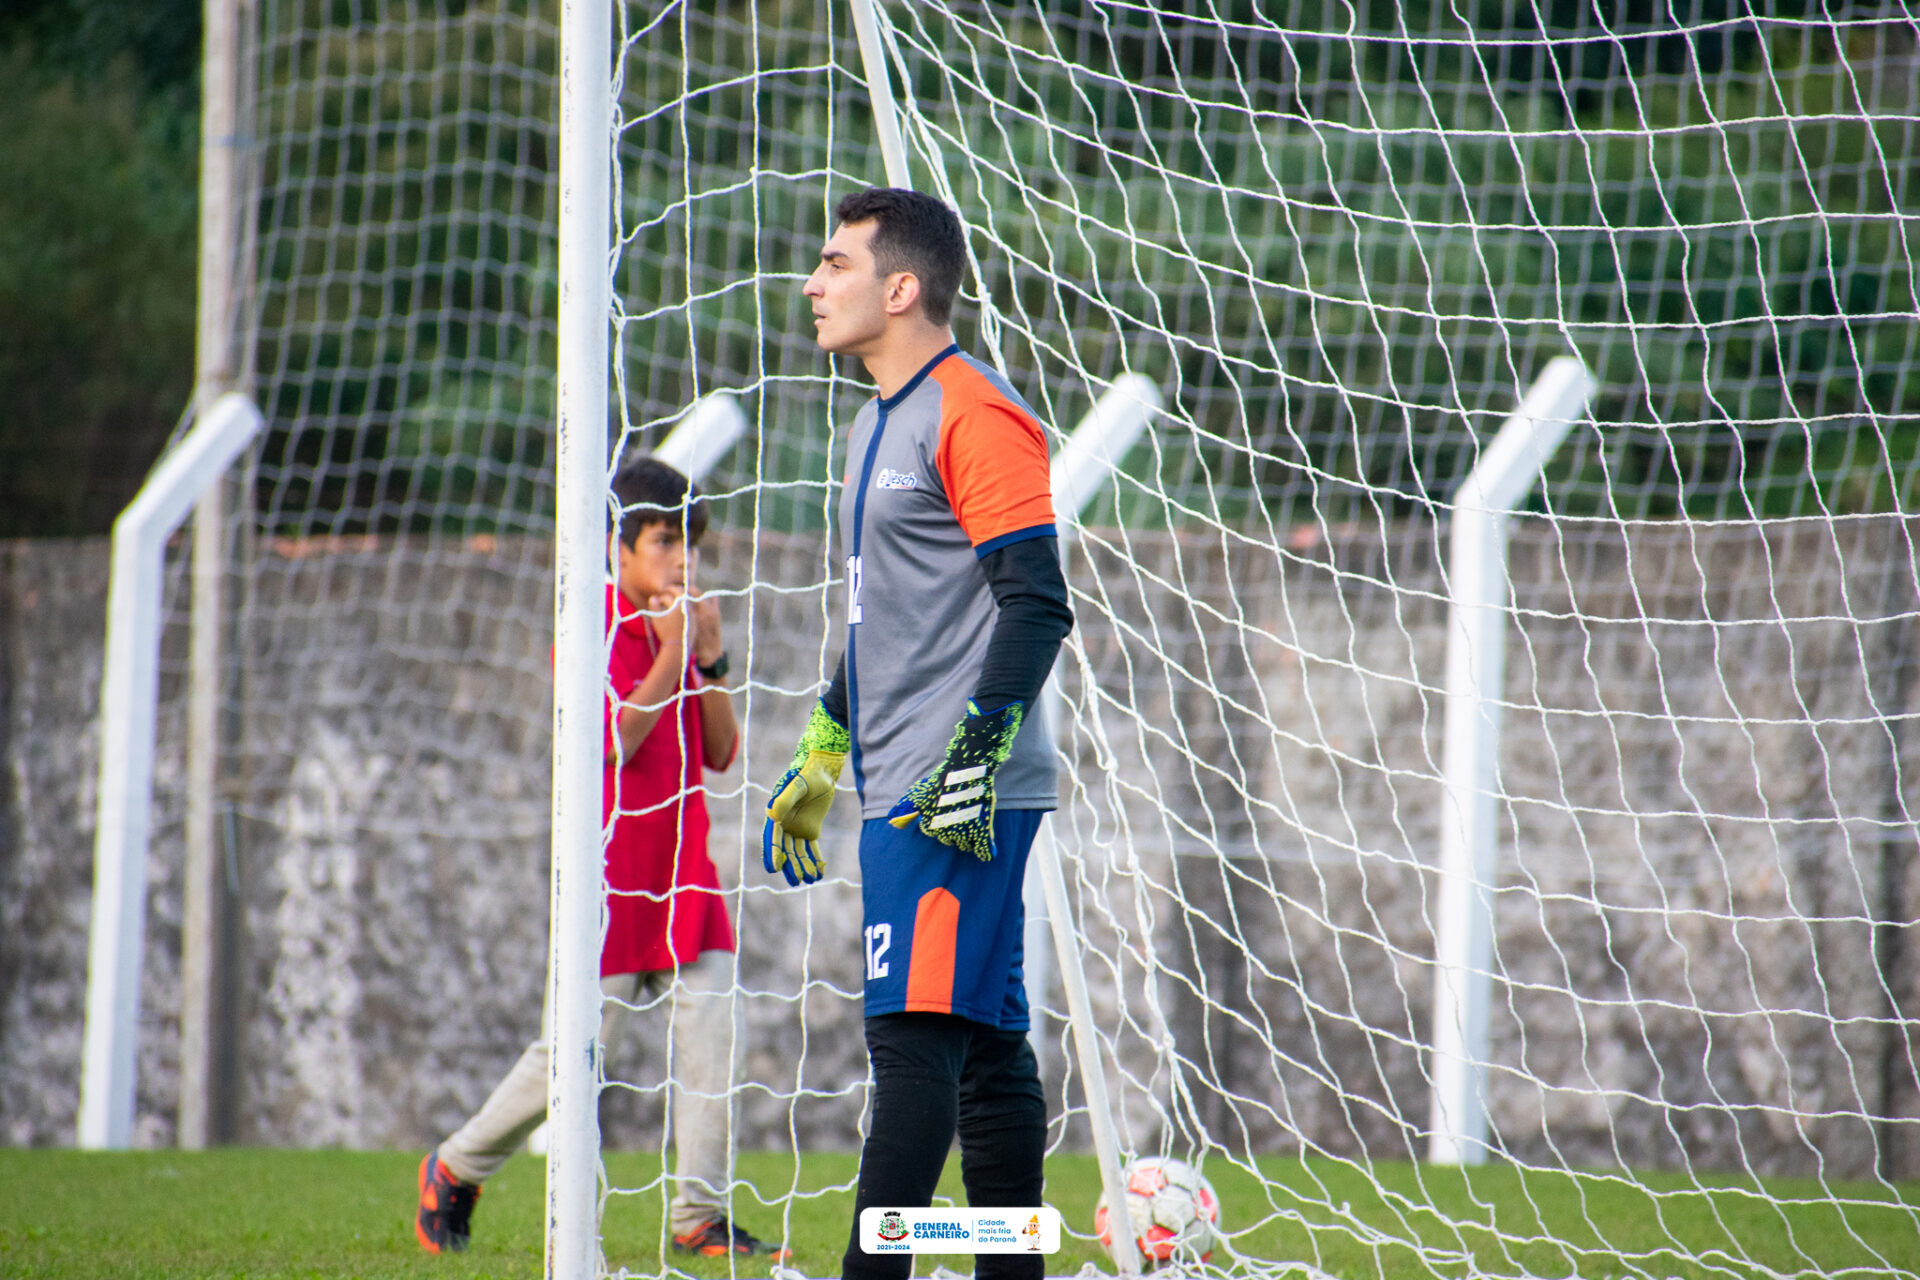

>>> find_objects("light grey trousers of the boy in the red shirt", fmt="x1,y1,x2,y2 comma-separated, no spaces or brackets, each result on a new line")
438,952,745,1234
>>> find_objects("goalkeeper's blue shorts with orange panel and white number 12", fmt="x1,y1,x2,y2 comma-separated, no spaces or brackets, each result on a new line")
860,810,1046,1031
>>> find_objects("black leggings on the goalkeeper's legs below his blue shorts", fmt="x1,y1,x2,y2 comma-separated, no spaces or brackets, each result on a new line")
841,1013,1046,1280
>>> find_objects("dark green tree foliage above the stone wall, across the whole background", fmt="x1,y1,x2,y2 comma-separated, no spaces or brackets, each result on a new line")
0,0,1920,532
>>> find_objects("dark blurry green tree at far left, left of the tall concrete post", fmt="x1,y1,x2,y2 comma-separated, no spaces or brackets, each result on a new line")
0,51,196,537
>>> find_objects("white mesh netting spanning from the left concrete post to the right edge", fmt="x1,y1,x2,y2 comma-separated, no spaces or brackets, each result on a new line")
131,0,1920,1276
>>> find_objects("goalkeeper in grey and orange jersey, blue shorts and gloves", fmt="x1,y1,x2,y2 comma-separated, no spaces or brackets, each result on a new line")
764,188,1073,1280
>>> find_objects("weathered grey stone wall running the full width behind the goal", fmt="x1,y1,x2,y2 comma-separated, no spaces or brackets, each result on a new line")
0,520,1920,1176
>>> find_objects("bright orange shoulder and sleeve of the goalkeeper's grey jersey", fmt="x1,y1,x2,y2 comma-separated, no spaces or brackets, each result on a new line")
933,361,1054,547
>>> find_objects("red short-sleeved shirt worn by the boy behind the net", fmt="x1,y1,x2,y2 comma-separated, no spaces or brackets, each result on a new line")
601,585,733,977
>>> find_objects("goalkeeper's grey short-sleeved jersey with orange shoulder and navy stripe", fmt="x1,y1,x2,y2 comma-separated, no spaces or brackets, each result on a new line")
839,345,1058,818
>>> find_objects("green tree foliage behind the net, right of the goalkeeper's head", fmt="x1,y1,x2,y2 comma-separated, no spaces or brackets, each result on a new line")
890,0,1920,518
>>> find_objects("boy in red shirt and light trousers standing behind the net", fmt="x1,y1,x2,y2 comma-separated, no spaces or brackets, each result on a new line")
415,459,787,1259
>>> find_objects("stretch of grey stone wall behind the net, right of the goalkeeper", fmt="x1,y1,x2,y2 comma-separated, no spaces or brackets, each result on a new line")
1062,520,1920,1176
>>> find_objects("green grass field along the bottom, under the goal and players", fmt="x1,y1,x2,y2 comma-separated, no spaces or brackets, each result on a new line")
0,1150,1920,1280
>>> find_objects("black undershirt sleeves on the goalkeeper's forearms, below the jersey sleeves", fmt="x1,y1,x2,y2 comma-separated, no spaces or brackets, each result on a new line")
820,537,1073,723
